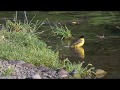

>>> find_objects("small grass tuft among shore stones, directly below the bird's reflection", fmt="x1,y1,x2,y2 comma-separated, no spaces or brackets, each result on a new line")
62,59,95,78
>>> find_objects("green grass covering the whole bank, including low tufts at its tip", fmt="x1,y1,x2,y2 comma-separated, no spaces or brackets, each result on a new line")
0,12,94,78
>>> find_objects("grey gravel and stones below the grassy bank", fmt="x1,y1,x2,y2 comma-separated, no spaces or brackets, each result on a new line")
0,59,69,79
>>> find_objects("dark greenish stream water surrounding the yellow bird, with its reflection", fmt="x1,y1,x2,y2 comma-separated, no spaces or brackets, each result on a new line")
0,12,120,79
